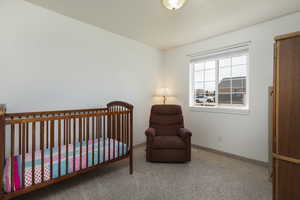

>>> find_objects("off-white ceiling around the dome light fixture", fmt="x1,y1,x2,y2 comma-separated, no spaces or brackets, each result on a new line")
27,0,300,49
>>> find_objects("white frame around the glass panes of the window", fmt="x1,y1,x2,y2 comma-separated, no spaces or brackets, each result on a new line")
189,43,250,114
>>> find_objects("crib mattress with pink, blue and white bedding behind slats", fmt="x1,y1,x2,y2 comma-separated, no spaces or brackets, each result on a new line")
3,138,127,192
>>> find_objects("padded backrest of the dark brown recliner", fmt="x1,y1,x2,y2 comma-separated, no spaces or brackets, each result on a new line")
149,105,184,136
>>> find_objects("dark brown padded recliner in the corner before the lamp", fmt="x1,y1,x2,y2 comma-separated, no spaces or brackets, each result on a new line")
145,105,192,162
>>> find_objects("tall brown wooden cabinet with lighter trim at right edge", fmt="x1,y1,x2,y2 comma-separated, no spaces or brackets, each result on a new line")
273,33,300,200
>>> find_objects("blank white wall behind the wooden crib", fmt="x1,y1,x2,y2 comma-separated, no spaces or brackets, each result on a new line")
0,0,162,144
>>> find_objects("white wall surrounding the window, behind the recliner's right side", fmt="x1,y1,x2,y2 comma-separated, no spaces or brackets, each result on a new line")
164,13,300,162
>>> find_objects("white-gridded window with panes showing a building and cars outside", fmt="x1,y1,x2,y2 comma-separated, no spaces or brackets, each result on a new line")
190,47,249,109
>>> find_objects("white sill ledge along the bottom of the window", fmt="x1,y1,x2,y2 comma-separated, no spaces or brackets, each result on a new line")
189,105,250,115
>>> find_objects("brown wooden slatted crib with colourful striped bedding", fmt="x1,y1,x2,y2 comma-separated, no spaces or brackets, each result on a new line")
0,101,133,199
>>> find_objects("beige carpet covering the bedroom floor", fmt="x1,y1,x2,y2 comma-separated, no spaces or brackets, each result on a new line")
14,146,272,200
